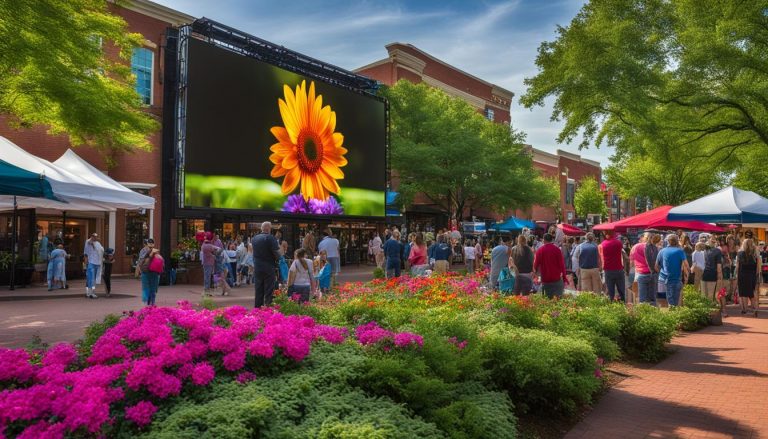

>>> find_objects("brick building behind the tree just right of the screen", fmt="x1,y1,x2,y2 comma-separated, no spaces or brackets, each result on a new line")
354,43,514,230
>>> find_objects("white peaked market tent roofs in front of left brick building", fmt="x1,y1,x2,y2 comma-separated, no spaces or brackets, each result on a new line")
0,136,155,212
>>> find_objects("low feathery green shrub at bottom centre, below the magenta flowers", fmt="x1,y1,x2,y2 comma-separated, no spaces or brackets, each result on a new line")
140,343,445,439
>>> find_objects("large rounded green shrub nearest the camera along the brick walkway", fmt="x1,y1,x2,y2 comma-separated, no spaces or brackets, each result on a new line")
480,324,600,413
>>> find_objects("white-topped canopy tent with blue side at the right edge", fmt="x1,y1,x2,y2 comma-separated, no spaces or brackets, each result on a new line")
667,186,768,226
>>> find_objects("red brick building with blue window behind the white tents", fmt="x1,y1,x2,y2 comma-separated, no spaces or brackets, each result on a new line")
0,0,194,273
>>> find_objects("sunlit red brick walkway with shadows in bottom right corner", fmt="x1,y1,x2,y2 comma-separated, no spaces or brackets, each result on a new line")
566,304,768,439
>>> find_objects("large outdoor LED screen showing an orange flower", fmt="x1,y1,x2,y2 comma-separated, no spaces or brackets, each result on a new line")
184,38,386,216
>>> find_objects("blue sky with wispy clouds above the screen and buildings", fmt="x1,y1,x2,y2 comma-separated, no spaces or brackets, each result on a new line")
155,0,610,166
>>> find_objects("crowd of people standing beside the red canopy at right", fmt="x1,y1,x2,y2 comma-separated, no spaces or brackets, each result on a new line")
488,227,768,316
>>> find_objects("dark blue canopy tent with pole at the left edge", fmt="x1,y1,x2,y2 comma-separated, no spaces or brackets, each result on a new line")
0,160,60,289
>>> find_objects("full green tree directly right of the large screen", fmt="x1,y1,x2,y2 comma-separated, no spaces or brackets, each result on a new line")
384,81,551,218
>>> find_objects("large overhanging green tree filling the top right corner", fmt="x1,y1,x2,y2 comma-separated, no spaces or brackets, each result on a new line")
521,0,768,157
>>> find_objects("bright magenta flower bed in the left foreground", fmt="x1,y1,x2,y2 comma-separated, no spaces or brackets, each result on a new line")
0,302,423,438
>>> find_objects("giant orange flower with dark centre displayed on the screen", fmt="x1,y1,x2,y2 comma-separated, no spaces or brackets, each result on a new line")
269,81,347,201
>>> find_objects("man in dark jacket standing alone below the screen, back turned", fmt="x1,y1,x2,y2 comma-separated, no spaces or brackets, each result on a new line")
251,221,280,308
